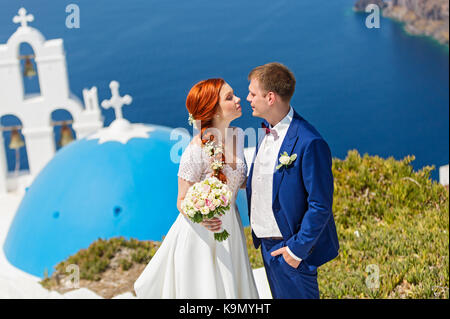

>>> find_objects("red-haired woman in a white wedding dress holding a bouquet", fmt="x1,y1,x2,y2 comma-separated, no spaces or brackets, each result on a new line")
134,79,258,299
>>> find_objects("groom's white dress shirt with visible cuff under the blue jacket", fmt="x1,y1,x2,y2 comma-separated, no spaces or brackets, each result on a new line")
250,107,301,261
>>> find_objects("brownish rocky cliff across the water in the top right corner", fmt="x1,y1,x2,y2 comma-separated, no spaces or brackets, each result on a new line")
355,0,449,45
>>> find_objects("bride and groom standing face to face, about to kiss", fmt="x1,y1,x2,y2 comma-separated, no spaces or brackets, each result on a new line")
134,63,339,299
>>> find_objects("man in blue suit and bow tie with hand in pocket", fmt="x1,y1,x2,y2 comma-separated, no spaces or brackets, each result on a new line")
247,63,339,298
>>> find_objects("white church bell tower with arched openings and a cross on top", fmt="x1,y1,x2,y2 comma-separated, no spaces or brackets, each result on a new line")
0,8,103,194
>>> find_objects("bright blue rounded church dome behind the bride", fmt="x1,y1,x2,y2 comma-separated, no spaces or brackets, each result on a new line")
4,124,248,277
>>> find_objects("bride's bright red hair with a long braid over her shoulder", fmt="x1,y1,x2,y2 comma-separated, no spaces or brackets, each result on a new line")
186,78,227,183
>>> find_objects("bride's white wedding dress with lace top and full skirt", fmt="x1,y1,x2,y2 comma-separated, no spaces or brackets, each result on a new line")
134,134,259,298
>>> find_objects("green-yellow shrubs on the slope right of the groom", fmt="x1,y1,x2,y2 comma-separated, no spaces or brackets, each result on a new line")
246,150,449,298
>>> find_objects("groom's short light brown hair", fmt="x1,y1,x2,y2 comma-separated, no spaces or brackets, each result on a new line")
248,62,295,102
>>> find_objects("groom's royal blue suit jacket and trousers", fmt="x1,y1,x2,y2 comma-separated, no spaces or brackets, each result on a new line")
247,111,339,298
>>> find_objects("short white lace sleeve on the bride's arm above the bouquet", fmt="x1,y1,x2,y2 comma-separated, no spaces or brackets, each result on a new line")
178,144,205,183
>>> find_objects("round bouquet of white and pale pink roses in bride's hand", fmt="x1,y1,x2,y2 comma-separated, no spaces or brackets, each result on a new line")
181,177,232,241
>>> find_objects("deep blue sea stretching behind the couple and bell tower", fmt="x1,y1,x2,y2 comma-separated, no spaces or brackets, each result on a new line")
0,0,449,179
